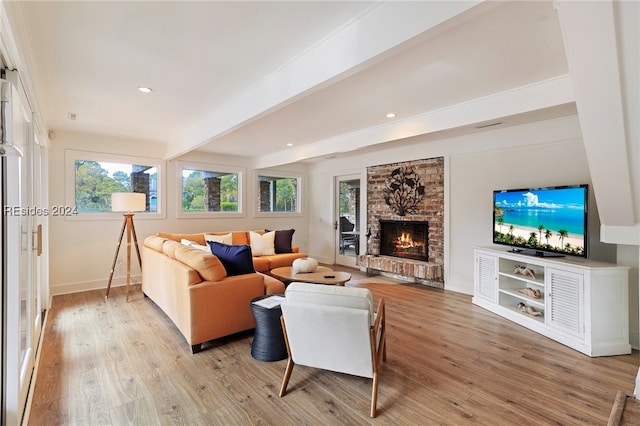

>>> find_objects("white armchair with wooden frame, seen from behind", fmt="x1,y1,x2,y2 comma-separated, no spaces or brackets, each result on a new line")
280,282,387,417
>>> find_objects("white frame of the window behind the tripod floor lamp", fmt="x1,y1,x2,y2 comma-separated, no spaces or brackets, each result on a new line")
64,149,166,220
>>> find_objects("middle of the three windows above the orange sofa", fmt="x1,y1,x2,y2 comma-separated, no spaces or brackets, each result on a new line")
178,163,242,217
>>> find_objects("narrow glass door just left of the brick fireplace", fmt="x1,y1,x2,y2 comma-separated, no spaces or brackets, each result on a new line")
334,175,361,267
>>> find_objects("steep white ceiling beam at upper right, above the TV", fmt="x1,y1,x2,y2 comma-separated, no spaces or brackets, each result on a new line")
556,0,636,227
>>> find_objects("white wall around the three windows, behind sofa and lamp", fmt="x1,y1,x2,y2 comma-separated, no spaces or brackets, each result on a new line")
49,132,308,295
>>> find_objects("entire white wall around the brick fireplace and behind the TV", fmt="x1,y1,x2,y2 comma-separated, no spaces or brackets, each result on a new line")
309,116,616,294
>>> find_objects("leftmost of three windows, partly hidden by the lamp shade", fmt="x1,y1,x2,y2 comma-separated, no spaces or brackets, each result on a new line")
60,151,161,218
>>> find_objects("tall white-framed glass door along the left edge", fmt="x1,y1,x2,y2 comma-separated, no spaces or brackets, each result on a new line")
0,76,37,424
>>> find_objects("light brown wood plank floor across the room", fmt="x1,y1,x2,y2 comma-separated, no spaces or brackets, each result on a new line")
28,270,639,425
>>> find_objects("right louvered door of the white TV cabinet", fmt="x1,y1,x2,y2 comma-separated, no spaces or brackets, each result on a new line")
546,268,584,337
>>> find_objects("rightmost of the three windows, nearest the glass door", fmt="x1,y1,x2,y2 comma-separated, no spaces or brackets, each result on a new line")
257,173,301,213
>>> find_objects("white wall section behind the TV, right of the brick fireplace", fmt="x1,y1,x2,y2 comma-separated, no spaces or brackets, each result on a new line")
445,140,616,293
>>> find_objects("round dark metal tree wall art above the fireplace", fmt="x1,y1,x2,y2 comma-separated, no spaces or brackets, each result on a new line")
383,166,424,216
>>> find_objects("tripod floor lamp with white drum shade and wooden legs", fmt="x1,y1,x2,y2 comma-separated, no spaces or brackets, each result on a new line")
104,192,147,302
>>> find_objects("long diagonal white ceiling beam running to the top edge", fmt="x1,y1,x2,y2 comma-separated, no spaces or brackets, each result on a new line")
166,0,484,159
